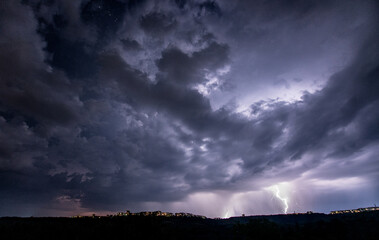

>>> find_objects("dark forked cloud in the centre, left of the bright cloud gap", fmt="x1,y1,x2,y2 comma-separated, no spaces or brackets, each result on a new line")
100,43,235,136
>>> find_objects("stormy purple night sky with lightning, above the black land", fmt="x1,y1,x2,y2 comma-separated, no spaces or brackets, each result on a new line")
0,0,379,217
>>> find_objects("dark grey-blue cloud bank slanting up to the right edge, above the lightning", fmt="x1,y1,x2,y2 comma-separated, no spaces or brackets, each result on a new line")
288,33,379,157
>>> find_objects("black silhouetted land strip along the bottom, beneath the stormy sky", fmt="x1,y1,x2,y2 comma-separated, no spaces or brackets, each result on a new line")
0,211,379,240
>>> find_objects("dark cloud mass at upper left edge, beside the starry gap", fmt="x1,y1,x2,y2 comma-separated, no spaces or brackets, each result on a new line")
0,0,76,127
